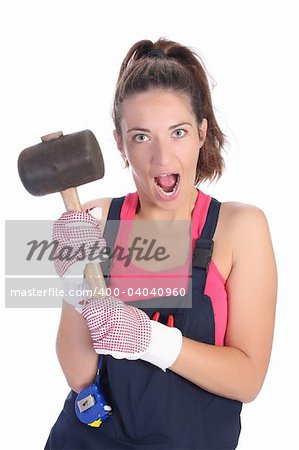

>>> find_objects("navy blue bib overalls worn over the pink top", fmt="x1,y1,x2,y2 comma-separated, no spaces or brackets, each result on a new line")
45,197,242,450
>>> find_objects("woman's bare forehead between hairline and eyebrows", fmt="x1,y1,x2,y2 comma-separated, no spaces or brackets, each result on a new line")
122,89,196,127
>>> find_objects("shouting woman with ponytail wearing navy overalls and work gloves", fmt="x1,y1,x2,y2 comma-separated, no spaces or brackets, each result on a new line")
46,39,277,450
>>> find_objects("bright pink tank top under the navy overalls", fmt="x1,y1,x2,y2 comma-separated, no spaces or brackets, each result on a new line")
110,190,227,346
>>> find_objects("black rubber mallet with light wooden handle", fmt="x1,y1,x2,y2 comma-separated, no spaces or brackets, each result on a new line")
18,130,106,289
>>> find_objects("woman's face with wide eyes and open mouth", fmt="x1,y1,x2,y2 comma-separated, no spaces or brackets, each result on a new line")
114,89,207,216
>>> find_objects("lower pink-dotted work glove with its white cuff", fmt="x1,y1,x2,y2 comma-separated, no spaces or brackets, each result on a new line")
82,297,183,371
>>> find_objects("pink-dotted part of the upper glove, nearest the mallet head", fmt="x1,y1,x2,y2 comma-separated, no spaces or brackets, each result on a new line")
53,211,106,277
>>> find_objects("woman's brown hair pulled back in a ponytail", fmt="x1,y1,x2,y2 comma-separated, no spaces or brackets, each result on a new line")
112,38,225,185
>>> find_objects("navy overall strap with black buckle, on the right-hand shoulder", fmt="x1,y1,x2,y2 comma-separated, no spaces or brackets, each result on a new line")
192,198,221,294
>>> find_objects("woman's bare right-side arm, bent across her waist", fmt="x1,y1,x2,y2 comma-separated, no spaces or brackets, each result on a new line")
171,205,277,402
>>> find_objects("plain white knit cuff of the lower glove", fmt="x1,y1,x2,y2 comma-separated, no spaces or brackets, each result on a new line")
140,320,183,372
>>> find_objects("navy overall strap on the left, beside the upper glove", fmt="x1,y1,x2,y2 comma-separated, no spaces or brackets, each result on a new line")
101,197,125,286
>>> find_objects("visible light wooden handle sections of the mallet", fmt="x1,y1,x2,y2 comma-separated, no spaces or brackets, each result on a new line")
60,188,106,297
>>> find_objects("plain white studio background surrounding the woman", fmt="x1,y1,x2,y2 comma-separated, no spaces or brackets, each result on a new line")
1,0,299,450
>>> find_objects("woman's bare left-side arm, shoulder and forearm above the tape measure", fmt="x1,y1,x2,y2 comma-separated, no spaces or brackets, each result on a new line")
56,199,111,392
